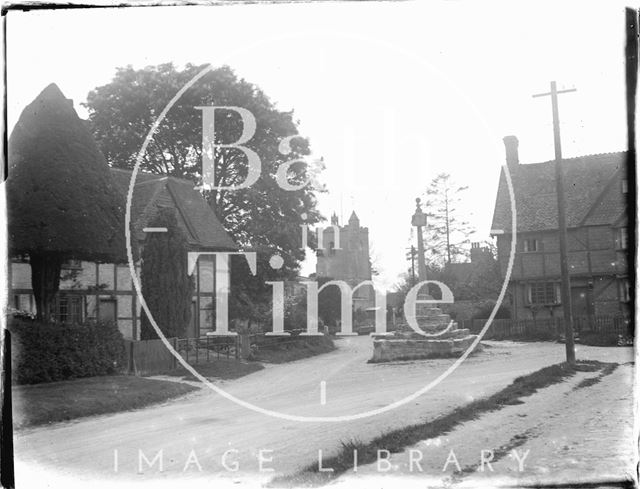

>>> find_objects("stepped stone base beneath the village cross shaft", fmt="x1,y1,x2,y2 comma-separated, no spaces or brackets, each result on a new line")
369,308,482,363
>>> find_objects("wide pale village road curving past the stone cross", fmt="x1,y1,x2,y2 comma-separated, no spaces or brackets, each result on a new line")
15,336,633,489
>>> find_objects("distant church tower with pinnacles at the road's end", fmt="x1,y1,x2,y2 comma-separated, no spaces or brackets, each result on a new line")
316,212,374,309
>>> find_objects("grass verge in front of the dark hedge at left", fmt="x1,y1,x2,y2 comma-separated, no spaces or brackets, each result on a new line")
12,375,198,428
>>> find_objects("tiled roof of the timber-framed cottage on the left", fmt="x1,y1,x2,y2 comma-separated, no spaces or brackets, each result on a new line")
111,168,238,250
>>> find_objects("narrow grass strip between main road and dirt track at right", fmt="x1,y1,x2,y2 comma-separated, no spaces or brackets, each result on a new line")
270,360,617,487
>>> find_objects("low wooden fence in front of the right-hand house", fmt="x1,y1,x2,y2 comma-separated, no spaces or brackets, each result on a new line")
458,316,634,340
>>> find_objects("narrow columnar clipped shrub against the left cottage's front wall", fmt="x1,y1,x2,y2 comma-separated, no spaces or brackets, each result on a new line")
140,209,194,340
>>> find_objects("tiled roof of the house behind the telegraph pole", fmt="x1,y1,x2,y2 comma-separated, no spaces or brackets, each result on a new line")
491,152,627,233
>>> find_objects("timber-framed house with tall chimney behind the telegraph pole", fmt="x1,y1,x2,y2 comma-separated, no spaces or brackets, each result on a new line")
491,136,630,319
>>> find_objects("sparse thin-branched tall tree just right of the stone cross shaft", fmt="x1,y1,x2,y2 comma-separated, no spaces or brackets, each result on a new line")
425,173,473,264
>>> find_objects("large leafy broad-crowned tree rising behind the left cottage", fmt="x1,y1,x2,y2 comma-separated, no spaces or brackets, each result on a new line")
85,63,321,298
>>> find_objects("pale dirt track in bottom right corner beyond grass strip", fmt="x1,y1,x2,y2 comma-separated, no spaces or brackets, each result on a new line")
331,356,637,489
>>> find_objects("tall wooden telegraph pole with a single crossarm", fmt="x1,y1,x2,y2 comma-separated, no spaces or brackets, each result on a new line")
533,81,576,363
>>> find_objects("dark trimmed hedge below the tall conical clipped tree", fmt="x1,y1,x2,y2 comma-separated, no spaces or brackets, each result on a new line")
9,318,125,384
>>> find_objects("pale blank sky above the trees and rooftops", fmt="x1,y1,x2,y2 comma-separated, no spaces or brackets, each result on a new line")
7,0,633,288
